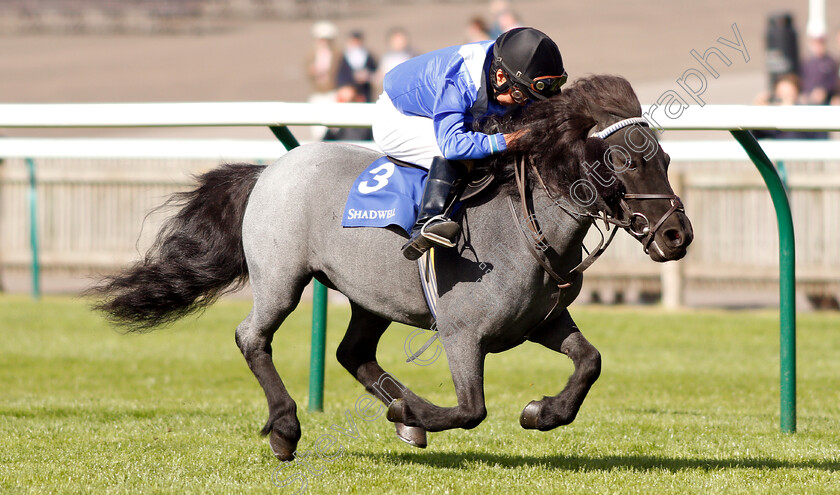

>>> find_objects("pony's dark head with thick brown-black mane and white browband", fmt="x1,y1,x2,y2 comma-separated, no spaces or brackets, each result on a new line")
488,75,694,261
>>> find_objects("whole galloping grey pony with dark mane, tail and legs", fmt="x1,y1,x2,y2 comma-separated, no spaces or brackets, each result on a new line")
91,76,693,460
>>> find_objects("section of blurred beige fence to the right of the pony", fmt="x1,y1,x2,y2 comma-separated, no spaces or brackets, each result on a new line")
583,148,840,309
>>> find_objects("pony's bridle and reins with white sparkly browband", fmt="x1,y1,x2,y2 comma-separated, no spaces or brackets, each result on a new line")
508,117,685,290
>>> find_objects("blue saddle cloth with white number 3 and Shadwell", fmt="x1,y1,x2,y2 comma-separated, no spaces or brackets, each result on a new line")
341,156,429,233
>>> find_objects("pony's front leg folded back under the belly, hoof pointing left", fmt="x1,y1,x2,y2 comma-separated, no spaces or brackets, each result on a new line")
388,334,487,431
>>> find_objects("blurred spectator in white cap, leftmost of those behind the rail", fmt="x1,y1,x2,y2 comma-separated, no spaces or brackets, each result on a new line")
306,21,341,140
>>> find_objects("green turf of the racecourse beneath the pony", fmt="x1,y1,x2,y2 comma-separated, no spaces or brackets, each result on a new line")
0,296,840,494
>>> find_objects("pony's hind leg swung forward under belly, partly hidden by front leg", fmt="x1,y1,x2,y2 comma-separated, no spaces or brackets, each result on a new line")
336,303,427,448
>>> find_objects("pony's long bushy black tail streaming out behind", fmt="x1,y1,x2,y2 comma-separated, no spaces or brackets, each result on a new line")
87,164,265,331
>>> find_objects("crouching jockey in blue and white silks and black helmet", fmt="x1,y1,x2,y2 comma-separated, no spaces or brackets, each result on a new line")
373,28,567,260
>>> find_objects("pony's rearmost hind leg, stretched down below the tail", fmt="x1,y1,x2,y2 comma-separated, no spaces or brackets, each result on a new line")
236,281,305,461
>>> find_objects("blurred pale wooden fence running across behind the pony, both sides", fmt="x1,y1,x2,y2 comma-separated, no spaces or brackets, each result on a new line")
0,134,840,308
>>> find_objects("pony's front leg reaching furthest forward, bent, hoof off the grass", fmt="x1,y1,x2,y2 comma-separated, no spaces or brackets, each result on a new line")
519,310,601,431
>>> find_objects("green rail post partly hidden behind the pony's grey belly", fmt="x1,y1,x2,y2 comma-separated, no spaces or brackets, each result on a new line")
271,125,327,411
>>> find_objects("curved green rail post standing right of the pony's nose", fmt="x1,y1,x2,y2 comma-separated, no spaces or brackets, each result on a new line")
731,131,796,433
